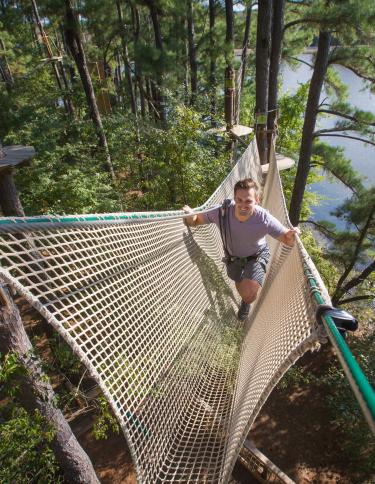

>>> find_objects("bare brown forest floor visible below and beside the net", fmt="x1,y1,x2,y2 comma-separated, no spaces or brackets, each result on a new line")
19,301,374,484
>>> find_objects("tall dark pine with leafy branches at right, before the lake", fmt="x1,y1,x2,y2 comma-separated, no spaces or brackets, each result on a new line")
284,0,375,225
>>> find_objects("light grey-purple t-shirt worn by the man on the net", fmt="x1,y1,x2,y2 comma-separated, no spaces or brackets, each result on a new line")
204,200,285,257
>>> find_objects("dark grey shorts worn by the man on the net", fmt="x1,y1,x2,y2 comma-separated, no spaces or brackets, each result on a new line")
227,247,270,286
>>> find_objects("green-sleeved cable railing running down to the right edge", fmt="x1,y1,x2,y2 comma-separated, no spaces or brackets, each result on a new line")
305,265,375,434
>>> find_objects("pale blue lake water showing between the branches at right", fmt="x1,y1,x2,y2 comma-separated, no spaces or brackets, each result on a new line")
281,54,375,228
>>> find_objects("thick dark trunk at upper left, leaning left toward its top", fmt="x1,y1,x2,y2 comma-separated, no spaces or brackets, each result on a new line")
65,0,116,183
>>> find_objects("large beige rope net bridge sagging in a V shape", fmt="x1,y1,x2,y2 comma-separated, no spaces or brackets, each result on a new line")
0,142,346,484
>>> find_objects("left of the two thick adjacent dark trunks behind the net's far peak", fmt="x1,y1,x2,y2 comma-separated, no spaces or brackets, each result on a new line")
255,0,272,165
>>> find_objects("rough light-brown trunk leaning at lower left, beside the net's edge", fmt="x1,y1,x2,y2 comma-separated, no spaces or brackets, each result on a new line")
0,278,99,484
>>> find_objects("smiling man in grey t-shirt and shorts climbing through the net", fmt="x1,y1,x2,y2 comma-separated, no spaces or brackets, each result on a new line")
183,178,300,321
